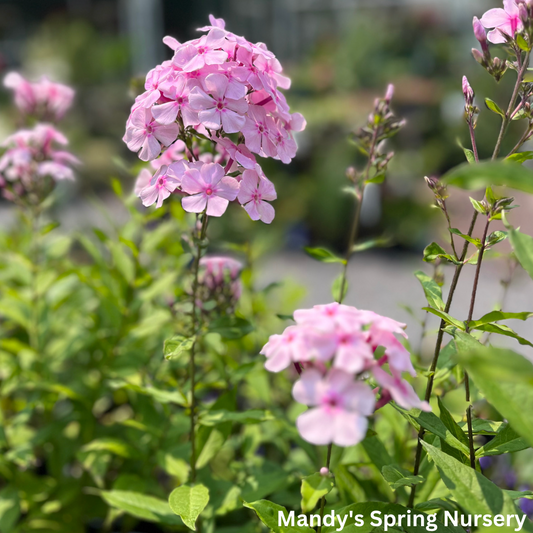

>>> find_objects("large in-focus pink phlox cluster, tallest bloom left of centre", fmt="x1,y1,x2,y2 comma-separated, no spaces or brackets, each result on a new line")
124,16,306,223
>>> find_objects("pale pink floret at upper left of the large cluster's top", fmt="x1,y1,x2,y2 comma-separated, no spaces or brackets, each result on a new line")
172,28,228,72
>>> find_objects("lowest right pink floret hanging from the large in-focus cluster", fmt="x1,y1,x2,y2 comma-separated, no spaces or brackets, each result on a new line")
238,170,277,224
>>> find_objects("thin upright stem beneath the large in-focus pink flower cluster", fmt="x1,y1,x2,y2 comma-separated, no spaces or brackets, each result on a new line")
189,212,209,483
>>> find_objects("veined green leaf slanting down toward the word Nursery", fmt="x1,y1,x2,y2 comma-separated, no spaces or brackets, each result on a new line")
422,441,533,531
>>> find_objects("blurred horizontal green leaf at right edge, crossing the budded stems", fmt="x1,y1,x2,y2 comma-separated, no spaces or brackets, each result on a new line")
441,161,533,194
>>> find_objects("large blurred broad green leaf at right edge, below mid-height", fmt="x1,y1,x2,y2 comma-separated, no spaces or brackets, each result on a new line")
456,332,533,445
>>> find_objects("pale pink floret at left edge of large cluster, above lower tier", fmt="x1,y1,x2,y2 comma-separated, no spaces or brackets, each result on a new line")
124,107,179,161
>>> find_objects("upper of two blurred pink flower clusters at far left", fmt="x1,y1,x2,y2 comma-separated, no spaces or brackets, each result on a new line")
4,72,75,122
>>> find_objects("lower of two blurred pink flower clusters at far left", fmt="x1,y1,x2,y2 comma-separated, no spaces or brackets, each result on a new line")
0,124,79,187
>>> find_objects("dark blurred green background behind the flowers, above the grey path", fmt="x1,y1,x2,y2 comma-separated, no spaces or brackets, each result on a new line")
0,0,518,251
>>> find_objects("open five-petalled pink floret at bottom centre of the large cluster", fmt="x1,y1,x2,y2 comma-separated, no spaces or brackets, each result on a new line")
181,163,239,217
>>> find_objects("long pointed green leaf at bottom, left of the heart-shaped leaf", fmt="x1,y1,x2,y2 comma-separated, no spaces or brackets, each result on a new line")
100,490,182,525
